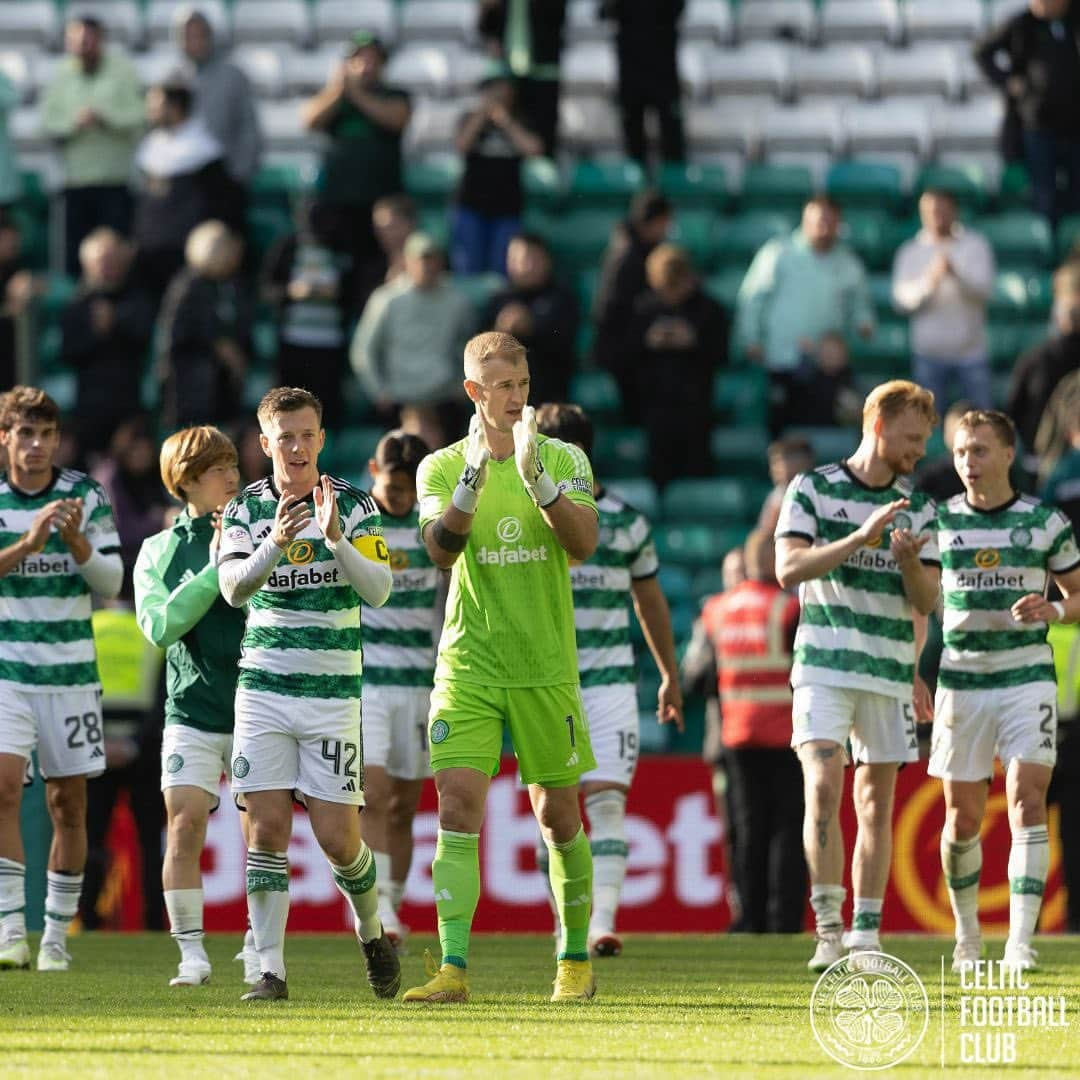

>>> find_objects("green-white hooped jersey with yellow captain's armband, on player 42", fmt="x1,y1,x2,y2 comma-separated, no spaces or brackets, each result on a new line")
218,476,389,699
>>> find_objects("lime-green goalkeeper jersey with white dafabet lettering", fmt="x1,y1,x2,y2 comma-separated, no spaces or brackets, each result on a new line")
417,435,596,687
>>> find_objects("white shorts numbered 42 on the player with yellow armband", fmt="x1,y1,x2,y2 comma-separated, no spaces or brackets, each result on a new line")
231,689,364,807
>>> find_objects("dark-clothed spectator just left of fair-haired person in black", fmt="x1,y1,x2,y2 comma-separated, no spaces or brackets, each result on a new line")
593,190,674,423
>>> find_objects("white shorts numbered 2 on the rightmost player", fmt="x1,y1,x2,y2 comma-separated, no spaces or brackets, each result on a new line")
927,683,1057,780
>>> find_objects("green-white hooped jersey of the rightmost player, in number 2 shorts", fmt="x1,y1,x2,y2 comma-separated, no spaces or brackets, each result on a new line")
937,495,1080,690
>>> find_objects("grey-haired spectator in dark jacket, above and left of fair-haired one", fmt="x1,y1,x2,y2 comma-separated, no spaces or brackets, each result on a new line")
60,226,160,455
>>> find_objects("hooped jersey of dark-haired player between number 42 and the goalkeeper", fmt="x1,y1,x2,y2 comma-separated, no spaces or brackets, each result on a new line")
364,509,438,688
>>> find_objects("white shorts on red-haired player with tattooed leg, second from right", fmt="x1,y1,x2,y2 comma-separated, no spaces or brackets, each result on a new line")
792,686,919,765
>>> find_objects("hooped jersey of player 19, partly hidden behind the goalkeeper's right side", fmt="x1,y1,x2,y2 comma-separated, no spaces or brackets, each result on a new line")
570,491,660,689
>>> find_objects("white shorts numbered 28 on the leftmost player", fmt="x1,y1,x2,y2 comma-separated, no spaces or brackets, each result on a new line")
0,685,105,780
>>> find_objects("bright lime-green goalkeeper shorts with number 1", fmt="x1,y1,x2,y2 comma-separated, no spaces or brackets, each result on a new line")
428,679,596,787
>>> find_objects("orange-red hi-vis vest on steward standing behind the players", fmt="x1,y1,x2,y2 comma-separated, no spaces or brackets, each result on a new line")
701,581,799,748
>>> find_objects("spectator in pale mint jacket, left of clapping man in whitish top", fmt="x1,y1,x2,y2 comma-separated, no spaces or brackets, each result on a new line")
735,195,874,434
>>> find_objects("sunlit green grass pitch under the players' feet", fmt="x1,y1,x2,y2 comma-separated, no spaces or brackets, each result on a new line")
0,934,1080,1080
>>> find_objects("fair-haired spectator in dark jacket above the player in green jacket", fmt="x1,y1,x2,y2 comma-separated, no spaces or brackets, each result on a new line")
158,221,252,431
